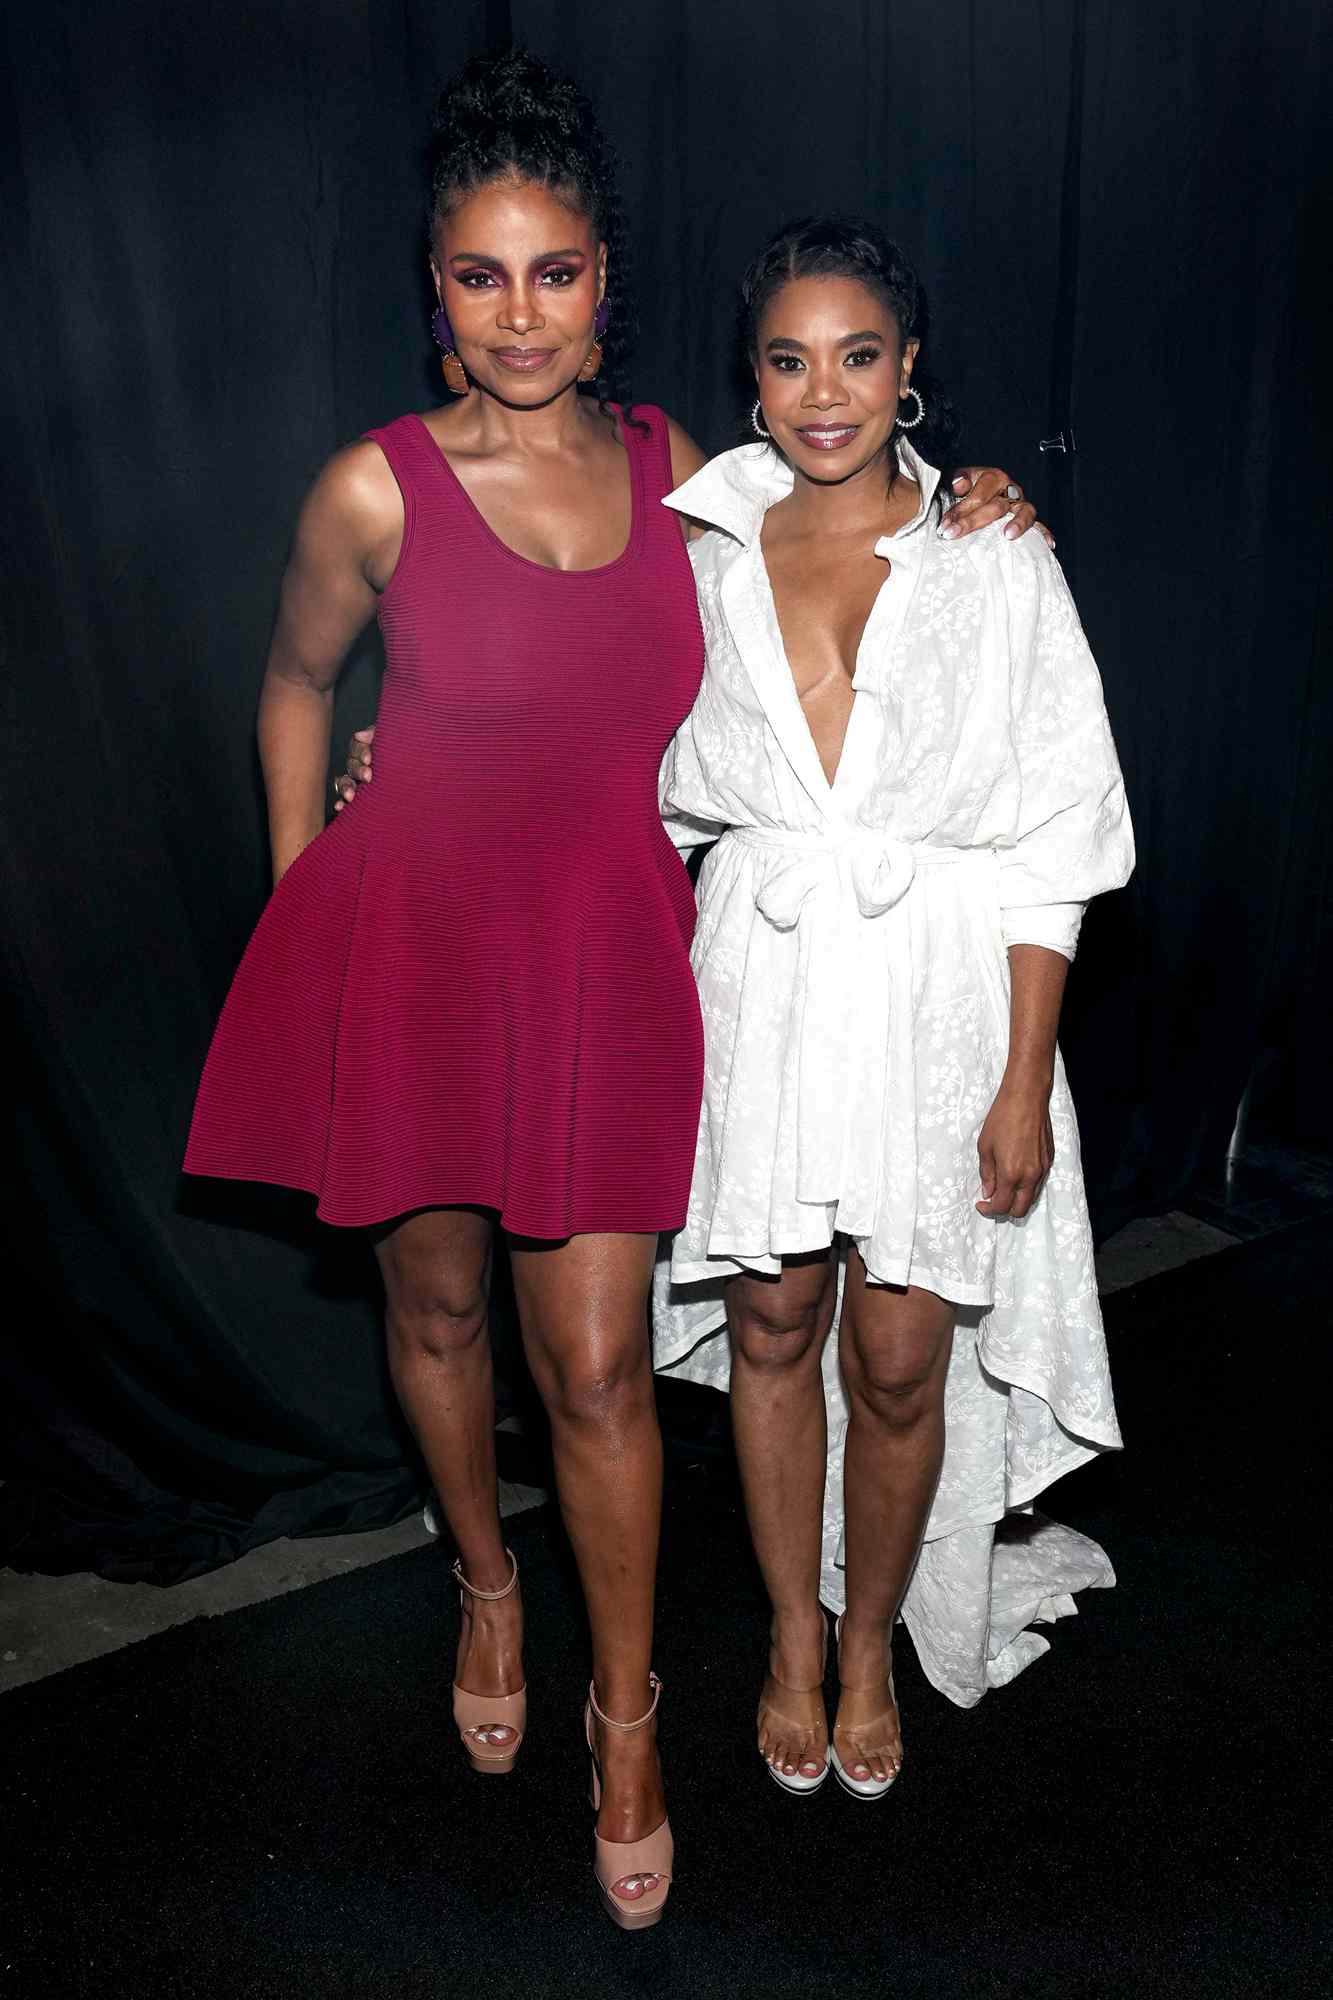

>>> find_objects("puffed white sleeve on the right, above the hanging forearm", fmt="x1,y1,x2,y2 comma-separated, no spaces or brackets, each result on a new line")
999,534,1135,958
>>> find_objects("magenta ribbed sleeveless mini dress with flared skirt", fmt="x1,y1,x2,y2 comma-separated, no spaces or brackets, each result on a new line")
184,406,703,1238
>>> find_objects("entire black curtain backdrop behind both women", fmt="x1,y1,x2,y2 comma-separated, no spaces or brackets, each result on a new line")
0,0,1333,1582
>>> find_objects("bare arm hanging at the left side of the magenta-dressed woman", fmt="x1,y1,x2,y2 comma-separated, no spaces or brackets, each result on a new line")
258,444,402,882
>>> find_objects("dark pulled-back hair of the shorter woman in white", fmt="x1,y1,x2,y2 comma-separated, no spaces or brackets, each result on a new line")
741,216,959,502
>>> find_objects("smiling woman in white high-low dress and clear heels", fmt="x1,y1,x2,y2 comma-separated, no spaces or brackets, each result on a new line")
654,222,1133,1798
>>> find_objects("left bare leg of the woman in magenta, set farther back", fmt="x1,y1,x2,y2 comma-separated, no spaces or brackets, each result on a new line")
376,1208,522,1744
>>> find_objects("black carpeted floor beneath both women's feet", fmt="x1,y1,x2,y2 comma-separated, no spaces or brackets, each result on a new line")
0,1220,1329,2000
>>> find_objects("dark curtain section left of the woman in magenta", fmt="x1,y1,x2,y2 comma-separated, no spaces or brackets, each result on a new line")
0,0,484,1580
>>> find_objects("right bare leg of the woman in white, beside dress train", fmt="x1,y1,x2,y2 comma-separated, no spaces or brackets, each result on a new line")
833,1250,955,1780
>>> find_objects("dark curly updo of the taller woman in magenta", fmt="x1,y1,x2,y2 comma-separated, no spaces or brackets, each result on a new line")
426,48,634,410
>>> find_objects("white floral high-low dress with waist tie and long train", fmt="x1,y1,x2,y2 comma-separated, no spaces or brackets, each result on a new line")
654,446,1133,1706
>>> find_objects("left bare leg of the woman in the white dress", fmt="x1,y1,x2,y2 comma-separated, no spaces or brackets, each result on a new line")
727,1250,837,1778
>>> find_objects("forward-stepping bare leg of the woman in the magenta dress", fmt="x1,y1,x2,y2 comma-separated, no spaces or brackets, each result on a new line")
512,1236,667,1900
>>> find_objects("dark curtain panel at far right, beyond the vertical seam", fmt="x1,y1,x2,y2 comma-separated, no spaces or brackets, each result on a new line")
1048,0,1333,1218
